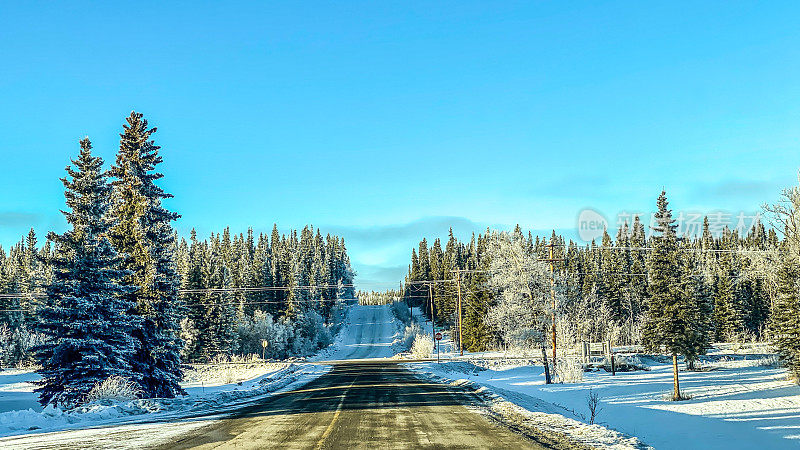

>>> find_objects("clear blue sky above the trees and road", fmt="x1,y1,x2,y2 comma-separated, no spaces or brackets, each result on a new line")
0,1,800,288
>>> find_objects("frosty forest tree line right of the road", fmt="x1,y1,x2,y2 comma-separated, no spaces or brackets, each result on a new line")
403,191,800,392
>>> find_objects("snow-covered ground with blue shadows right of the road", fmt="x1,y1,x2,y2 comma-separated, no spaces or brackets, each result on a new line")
411,346,800,449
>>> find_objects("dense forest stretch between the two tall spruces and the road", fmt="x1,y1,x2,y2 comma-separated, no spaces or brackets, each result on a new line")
176,225,355,361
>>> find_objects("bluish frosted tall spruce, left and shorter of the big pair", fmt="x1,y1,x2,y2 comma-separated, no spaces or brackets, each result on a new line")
33,138,136,406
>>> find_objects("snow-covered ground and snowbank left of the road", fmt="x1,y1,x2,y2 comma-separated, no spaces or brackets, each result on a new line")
0,364,329,449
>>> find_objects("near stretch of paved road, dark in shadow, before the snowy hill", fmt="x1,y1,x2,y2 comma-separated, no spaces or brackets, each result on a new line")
163,362,542,449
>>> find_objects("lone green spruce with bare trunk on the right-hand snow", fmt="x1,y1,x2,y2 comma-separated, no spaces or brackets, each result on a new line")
642,191,709,400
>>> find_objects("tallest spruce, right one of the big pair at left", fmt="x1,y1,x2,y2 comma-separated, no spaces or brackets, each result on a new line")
111,112,185,397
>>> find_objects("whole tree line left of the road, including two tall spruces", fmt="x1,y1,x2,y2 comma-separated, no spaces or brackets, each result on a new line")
0,112,354,406
